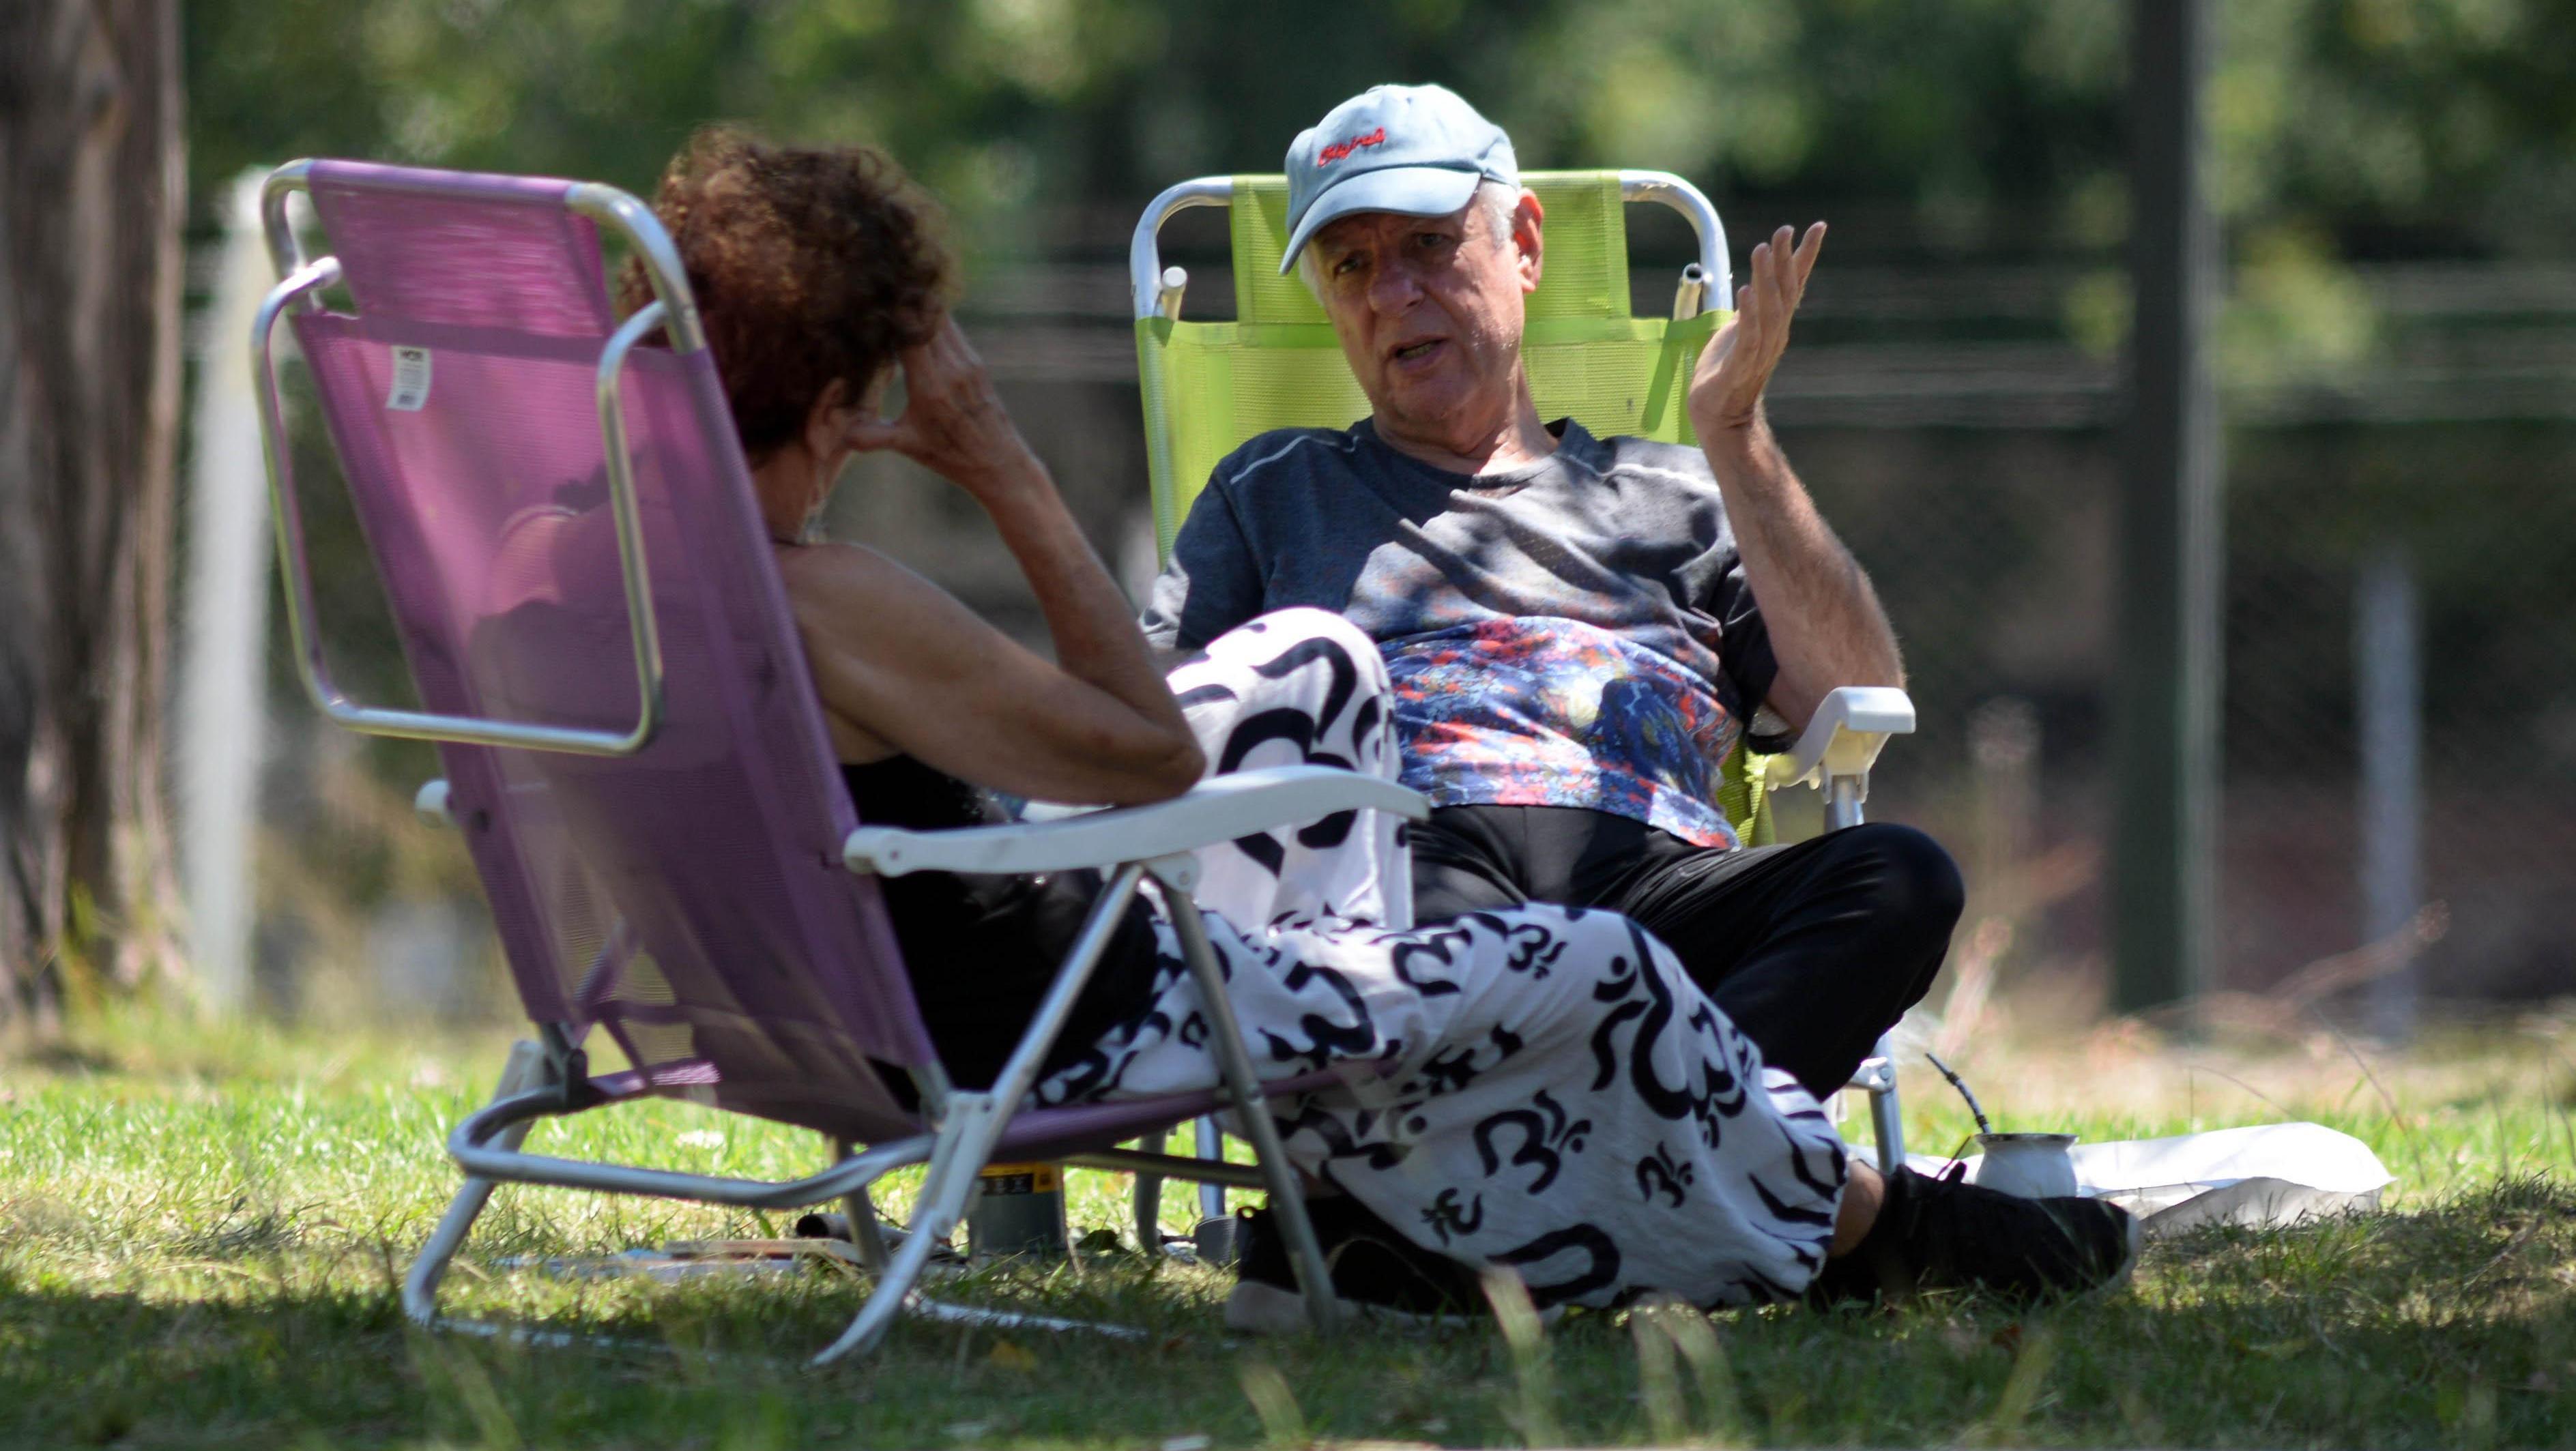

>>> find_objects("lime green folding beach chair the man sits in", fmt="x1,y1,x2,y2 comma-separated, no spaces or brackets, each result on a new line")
1128,170,1914,1248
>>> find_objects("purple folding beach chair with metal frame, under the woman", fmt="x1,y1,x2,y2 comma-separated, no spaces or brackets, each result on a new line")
252,160,1425,1364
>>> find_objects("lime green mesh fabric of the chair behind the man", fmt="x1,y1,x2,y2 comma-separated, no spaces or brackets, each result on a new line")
1136,170,1769,845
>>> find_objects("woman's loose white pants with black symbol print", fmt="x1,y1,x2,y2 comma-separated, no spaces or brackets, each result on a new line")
1038,611,1844,1306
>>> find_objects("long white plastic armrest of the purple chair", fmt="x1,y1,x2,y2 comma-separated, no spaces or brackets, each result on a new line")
840,765,1430,877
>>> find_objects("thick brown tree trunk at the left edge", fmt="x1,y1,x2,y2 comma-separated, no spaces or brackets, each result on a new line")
0,0,188,1026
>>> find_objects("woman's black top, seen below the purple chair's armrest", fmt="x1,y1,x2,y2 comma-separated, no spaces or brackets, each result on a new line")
840,755,1154,1087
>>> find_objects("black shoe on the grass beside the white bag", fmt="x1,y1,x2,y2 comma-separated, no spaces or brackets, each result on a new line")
1808,1165,2138,1304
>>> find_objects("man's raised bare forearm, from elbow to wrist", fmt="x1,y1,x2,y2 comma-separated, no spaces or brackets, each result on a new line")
1701,412,1904,727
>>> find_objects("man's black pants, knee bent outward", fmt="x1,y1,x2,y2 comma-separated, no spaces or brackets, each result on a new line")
1412,807,1963,1098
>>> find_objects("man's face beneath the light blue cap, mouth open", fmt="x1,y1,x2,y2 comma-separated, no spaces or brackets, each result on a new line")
1306,193,1538,451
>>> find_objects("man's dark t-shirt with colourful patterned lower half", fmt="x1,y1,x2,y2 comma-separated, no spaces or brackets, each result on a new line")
1144,420,1778,845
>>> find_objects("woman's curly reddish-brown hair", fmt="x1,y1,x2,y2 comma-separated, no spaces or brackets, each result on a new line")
618,126,948,464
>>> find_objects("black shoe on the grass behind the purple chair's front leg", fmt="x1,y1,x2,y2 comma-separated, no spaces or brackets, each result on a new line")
1226,1196,1484,1335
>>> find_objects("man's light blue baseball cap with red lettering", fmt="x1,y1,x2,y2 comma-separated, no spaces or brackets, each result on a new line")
1280,85,1520,276
